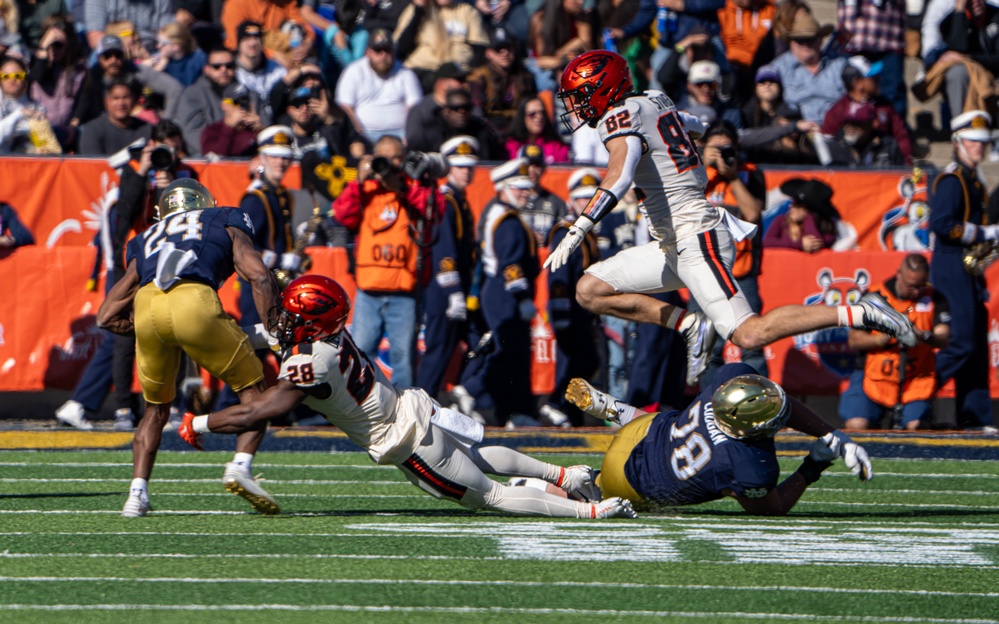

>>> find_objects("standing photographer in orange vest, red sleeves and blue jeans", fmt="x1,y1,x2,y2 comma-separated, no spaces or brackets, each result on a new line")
333,135,449,388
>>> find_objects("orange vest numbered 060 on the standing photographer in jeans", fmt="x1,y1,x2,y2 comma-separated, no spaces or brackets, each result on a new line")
354,180,417,292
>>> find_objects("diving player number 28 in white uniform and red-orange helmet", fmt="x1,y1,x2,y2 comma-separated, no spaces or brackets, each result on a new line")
178,275,636,518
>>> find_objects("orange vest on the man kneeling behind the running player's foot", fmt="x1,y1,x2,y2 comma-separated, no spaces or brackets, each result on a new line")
864,284,937,407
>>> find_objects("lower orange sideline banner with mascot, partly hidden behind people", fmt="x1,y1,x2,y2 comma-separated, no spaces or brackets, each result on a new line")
0,247,999,398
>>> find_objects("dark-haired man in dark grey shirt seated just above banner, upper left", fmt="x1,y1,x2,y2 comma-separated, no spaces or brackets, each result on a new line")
80,78,152,156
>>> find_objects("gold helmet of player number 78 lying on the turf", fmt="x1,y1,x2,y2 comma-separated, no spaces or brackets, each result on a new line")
711,375,791,440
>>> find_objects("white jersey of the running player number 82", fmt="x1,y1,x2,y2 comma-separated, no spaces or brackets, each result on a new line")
597,91,722,244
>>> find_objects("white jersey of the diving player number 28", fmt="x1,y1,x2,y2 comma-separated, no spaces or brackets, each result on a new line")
278,331,430,463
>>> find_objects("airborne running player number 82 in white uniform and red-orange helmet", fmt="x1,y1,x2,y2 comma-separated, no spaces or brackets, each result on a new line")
545,50,916,385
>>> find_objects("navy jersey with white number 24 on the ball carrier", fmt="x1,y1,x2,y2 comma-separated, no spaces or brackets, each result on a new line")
126,208,253,290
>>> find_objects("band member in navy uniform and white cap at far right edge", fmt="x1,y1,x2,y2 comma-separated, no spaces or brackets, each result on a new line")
930,110,999,433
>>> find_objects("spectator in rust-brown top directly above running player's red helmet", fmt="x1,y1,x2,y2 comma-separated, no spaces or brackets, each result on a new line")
527,0,600,91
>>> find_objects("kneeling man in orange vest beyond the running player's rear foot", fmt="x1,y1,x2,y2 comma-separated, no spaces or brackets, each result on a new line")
839,254,950,430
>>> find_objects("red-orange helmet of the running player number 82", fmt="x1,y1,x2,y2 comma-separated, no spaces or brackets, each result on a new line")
557,50,635,132
